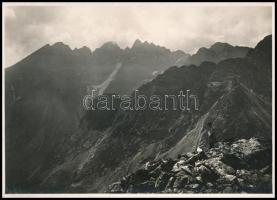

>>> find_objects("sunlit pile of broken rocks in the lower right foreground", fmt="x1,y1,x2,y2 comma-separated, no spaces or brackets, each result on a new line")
107,138,272,193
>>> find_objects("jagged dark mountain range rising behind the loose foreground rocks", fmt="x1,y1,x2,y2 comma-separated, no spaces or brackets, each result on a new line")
5,36,272,193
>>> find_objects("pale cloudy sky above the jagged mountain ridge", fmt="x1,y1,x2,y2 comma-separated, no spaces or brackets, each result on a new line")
4,3,272,66
